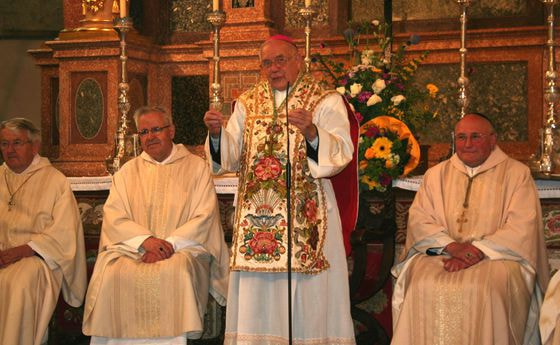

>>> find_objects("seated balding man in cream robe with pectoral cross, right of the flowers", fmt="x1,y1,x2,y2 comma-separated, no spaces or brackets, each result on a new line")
392,114,549,345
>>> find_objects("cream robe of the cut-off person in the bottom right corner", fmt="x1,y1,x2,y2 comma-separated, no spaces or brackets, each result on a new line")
539,271,560,345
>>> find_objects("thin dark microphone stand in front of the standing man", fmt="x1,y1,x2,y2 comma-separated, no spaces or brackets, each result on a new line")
285,82,293,345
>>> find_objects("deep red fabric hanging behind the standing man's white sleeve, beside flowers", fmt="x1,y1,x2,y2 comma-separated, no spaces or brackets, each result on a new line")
330,97,360,256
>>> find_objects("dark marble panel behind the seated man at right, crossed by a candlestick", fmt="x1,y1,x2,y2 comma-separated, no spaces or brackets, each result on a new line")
410,62,529,144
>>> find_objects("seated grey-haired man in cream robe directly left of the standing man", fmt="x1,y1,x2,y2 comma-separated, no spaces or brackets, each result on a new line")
83,107,229,344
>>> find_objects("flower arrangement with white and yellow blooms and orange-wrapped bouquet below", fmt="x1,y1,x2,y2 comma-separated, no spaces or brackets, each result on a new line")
314,20,439,191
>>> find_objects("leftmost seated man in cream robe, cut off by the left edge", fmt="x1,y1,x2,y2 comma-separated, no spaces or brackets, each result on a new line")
0,118,86,345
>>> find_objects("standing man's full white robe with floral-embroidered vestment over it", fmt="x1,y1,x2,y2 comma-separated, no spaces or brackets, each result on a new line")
207,76,357,345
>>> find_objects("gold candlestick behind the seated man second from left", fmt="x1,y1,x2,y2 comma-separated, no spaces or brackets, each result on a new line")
106,17,140,174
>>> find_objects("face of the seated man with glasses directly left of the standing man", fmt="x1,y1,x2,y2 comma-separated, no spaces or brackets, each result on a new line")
138,112,175,162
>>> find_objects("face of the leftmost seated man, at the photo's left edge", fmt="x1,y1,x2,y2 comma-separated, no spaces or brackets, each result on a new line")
0,128,39,174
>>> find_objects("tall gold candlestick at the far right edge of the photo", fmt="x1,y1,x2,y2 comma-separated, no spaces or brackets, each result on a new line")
540,0,559,174
